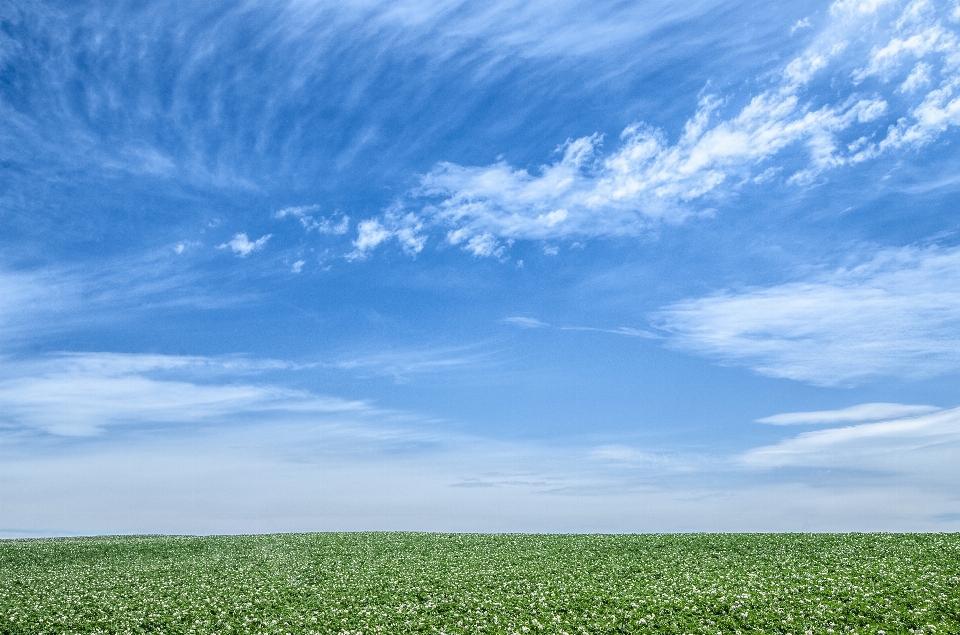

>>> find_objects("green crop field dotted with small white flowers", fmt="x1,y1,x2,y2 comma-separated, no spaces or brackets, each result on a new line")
0,533,960,635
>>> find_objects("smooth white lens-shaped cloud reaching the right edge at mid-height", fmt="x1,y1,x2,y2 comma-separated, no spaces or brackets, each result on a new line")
656,242,960,385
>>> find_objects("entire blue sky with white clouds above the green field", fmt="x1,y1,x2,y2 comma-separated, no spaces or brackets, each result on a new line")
0,0,960,537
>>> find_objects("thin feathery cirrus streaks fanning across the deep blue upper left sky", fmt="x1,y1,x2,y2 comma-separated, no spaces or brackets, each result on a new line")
0,0,718,201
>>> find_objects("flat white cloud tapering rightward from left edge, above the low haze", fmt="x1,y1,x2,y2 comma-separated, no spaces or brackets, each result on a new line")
0,354,372,436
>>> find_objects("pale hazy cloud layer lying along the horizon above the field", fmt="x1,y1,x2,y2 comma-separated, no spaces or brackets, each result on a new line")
0,402,958,536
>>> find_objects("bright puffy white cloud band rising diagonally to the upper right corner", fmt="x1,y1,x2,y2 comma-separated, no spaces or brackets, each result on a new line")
358,0,960,257
